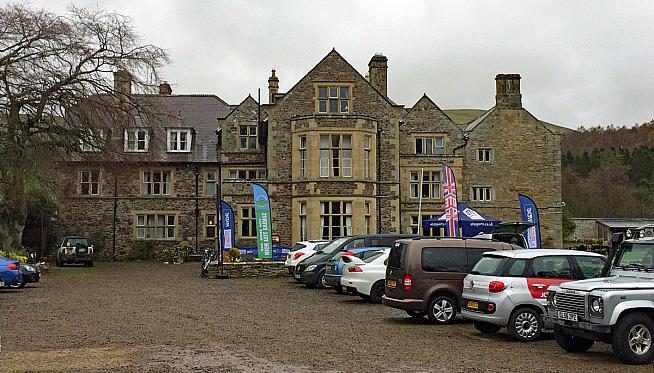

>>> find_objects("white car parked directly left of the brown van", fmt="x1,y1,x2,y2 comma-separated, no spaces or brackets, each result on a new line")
341,248,391,303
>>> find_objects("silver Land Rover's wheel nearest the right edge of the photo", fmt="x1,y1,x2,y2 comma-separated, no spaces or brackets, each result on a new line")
612,312,654,365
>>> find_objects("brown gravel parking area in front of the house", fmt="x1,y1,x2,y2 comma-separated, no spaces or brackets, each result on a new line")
0,263,654,373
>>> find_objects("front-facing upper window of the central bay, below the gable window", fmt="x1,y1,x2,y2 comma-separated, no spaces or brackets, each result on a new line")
320,135,352,177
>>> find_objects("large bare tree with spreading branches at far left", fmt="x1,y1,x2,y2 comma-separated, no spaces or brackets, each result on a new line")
0,3,168,248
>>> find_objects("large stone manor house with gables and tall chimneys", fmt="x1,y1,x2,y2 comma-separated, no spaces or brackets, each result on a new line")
58,50,562,258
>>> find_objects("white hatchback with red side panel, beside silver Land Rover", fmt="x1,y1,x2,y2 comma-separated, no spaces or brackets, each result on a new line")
461,249,605,342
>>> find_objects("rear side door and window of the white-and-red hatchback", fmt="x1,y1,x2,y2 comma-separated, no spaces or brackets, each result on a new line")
527,255,575,306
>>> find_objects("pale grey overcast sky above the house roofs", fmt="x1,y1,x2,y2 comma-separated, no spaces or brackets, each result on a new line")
31,0,654,128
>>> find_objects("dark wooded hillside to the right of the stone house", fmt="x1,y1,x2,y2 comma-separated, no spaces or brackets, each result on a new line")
562,121,654,218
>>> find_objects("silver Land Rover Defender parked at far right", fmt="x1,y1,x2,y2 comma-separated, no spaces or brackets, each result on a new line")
546,228,654,364
